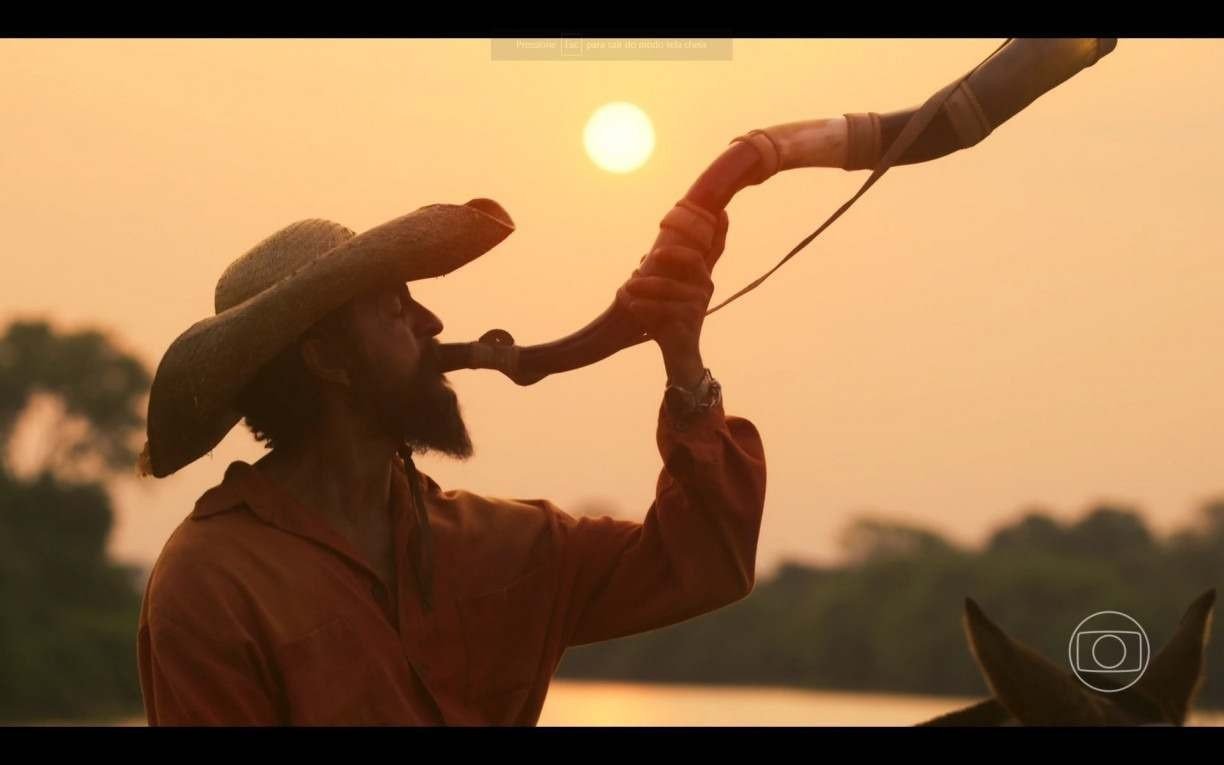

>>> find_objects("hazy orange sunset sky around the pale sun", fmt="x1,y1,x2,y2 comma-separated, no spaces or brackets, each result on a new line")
0,39,1224,573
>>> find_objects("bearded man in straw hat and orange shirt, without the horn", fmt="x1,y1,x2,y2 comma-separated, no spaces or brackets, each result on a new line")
138,200,765,725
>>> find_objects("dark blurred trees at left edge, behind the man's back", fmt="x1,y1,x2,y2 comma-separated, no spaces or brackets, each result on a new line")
0,322,149,720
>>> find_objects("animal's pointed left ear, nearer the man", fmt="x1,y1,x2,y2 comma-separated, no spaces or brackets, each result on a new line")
965,599,1111,726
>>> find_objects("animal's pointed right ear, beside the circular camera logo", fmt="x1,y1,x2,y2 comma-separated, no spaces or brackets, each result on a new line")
1136,589,1215,725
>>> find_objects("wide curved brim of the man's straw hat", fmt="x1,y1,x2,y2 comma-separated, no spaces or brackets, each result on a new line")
140,200,514,477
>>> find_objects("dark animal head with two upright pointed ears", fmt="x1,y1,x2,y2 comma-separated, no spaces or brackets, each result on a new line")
922,590,1215,726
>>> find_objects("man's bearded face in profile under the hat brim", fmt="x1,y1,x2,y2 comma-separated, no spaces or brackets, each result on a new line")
348,285,472,459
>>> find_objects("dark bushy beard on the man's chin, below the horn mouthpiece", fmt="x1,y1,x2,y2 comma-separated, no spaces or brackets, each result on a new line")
355,345,472,459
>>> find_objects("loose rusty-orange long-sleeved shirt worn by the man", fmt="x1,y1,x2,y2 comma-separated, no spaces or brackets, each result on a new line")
138,396,765,725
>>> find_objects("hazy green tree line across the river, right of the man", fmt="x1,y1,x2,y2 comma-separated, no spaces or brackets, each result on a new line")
558,501,1224,707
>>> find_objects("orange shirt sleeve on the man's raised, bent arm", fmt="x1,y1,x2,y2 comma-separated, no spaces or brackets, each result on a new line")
557,391,765,645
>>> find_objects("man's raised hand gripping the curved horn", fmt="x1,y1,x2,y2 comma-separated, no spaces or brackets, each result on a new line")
617,211,730,388
